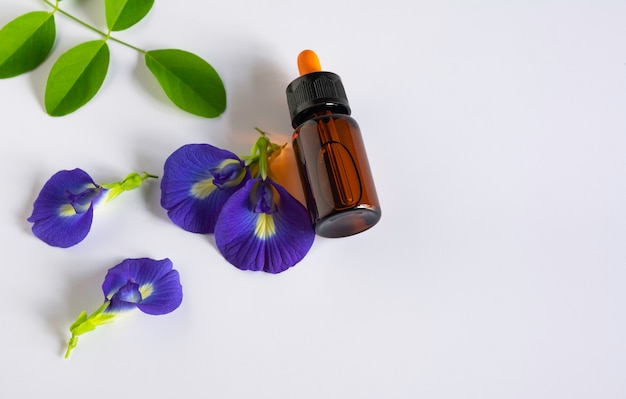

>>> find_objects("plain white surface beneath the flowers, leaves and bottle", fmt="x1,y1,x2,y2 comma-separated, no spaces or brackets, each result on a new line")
0,0,626,399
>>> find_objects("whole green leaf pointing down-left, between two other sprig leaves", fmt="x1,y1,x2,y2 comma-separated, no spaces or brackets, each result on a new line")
44,40,109,116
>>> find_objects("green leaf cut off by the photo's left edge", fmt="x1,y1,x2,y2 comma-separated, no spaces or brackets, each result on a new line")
0,11,56,79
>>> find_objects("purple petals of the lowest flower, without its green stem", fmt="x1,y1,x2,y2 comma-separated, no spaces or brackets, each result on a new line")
102,258,183,315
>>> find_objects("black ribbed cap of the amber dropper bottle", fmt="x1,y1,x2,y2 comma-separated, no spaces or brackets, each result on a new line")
287,71,350,128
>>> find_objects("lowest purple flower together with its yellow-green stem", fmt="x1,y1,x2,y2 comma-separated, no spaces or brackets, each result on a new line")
65,258,183,358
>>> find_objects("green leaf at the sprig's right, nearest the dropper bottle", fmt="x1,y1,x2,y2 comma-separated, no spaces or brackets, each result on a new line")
145,49,226,118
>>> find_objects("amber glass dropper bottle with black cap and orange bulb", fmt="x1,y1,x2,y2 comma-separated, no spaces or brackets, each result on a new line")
287,50,381,237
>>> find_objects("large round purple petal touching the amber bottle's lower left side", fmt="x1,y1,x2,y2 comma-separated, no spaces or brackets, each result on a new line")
215,179,315,273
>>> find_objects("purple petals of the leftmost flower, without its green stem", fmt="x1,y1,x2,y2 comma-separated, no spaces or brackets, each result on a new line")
28,169,107,248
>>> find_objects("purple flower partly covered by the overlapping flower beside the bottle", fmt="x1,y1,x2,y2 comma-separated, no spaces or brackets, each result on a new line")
161,144,250,233
